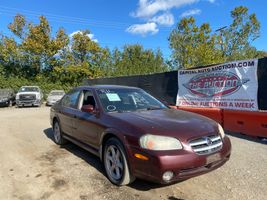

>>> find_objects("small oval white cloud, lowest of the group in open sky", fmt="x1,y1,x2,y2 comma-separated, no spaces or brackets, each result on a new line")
126,22,159,36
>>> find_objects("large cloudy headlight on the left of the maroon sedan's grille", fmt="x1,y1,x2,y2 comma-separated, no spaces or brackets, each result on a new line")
140,134,183,151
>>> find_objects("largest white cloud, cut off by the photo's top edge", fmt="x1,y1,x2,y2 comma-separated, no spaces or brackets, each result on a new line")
132,0,199,18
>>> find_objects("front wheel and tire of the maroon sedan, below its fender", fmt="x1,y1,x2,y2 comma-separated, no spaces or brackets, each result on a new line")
103,138,135,186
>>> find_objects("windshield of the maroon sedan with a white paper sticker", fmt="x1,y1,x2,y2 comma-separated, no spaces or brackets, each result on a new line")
97,89,167,112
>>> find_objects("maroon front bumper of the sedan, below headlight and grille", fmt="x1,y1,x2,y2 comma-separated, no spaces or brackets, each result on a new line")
131,136,231,184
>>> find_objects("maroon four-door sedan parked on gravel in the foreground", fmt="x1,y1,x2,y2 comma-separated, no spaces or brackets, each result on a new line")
50,85,231,185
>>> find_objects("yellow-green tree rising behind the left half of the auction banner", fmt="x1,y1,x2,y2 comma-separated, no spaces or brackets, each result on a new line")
169,17,222,68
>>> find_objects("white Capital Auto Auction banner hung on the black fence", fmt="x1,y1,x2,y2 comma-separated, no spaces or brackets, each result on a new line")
176,59,258,111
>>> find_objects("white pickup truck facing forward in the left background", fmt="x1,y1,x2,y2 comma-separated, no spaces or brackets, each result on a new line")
16,86,43,107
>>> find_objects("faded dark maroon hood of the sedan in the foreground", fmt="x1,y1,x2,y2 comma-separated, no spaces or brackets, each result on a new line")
112,109,218,141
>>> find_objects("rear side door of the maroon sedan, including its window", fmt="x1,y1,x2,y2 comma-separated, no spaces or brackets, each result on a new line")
58,90,80,136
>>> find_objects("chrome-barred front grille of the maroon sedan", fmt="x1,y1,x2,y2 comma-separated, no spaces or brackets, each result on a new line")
189,135,222,155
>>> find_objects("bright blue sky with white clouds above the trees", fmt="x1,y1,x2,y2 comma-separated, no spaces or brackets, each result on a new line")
0,0,267,58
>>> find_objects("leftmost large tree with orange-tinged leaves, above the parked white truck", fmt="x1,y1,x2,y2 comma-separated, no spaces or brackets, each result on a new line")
1,14,69,78
